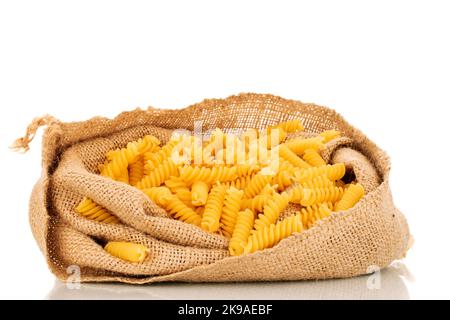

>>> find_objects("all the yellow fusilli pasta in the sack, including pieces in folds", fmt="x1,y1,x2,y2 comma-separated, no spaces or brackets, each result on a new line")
75,119,364,263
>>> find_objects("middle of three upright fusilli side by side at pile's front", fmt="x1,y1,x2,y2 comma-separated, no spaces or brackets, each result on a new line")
220,187,244,238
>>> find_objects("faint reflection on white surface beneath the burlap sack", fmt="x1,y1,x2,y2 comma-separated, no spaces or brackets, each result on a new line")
47,264,409,300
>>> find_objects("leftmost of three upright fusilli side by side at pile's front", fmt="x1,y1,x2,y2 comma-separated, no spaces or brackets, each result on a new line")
201,184,226,232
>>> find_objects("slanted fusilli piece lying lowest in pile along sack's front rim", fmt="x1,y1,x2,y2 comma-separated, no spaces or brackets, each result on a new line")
244,214,304,253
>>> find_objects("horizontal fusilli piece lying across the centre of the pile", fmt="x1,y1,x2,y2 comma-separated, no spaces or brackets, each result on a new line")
179,166,237,184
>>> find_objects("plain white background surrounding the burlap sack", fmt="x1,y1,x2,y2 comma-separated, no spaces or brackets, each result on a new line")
0,0,450,299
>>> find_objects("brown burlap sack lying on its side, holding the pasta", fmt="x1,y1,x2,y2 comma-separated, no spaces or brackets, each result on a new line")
15,93,412,283
